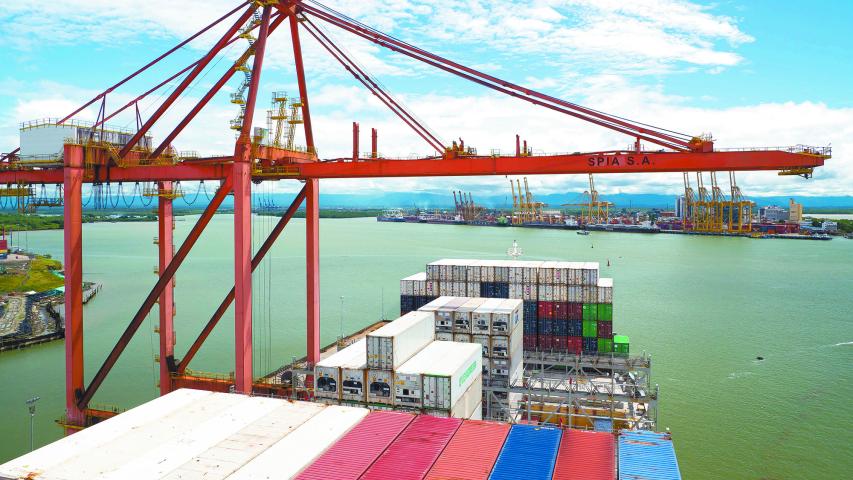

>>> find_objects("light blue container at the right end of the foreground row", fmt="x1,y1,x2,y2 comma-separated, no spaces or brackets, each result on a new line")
619,431,681,480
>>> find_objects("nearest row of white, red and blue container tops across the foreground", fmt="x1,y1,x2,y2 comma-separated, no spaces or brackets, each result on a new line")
0,389,680,480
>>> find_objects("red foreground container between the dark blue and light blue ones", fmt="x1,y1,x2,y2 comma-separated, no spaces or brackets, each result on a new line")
551,429,616,480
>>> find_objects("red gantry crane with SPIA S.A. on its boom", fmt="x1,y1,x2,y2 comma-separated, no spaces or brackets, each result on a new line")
0,0,831,426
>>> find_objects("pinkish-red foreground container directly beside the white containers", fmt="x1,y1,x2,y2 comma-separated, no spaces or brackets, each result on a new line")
296,412,415,480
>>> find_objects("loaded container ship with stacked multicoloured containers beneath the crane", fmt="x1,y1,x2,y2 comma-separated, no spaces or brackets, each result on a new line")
0,259,681,480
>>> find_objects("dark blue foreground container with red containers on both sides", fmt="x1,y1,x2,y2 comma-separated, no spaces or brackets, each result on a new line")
489,425,562,480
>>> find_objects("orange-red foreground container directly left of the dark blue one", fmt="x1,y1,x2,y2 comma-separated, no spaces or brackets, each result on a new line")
426,420,509,480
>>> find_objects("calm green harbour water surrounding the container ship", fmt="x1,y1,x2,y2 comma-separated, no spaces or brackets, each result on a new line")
0,216,853,479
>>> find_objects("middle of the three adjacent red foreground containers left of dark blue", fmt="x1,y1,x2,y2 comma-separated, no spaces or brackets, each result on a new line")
362,415,462,480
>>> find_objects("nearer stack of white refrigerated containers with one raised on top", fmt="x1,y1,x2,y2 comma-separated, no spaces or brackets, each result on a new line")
314,312,483,419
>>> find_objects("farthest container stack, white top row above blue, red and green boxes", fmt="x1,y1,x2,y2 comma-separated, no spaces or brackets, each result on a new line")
400,259,629,355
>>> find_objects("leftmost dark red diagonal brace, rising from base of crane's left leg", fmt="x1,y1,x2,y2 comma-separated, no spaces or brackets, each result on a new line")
76,175,231,411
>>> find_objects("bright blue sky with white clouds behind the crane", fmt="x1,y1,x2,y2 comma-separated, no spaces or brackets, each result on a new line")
0,0,853,198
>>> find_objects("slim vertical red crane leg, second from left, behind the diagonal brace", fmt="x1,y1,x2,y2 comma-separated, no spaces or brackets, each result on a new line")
157,182,175,395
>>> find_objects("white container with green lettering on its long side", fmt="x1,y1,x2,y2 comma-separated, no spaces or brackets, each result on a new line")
414,342,483,410
